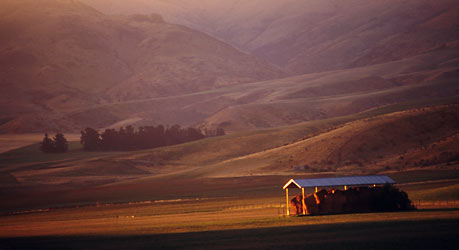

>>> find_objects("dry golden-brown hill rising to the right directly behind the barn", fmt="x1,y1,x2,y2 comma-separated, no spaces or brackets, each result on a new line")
196,105,459,177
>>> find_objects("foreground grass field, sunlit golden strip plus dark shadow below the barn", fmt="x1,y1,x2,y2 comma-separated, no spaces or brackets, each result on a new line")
0,200,459,249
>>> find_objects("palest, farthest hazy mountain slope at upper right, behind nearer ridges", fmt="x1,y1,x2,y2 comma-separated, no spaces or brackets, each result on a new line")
85,0,459,74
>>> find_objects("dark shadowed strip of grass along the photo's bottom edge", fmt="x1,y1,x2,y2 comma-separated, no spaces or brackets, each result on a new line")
4,219,459,250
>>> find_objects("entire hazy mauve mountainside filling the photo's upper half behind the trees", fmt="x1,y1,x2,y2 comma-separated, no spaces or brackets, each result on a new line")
0,0,459,133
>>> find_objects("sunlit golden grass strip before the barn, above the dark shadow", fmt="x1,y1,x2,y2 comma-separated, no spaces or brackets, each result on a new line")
0,195,459,238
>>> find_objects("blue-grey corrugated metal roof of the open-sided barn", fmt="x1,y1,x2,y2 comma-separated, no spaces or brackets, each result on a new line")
284,175,395,189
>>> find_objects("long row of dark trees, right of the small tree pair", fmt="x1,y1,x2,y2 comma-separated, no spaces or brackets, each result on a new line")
81,125,219,151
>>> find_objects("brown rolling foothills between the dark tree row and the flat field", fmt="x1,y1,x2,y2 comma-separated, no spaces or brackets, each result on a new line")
1,102,459,182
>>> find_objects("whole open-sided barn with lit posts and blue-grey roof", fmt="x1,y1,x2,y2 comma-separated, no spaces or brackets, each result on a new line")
283,175,414,215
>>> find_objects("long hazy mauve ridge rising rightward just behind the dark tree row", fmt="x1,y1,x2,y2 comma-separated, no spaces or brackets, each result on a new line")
0,44,459,133
